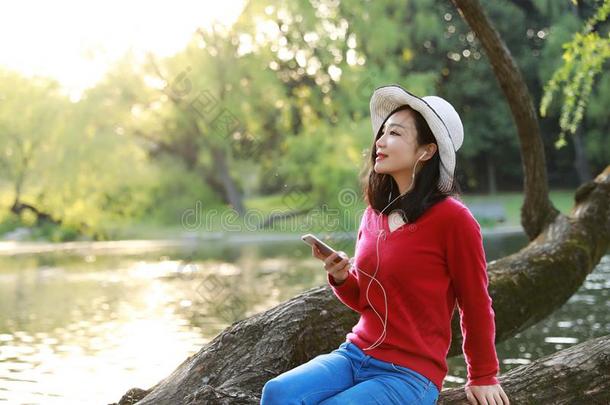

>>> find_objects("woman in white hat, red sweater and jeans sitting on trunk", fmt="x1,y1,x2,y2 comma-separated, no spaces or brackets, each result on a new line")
261,85,509,405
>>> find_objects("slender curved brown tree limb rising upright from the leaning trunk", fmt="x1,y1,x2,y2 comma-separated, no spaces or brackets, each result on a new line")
452,0,559,240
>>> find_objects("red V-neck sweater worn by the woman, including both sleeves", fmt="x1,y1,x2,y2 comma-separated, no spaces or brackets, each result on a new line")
327,197,499,392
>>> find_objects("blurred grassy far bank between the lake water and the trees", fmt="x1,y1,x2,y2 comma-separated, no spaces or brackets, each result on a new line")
0,190,574,245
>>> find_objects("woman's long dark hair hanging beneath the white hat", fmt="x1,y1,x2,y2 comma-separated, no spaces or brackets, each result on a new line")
363,105,462,222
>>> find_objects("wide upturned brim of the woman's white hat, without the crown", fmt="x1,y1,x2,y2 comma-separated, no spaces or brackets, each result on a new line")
370,85,455,191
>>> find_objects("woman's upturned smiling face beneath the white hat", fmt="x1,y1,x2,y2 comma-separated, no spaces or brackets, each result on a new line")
374,110,427,177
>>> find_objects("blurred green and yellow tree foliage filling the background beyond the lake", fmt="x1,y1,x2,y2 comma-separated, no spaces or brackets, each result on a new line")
0,0,610,240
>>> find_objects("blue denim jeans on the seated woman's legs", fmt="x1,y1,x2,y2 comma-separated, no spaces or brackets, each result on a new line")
261,341,439,405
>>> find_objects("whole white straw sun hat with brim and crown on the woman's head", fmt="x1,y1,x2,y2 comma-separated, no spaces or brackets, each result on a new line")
370,84,464,191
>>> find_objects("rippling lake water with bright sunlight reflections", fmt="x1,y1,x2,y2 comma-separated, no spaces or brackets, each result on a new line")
0,235,610,405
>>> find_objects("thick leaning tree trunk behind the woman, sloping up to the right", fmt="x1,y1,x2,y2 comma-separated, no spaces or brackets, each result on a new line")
110,166,610,405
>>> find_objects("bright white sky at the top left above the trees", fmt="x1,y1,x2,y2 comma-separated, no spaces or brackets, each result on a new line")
0,0,244,100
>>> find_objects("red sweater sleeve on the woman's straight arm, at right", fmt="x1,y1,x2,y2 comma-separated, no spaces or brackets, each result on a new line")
446,208,499,386
